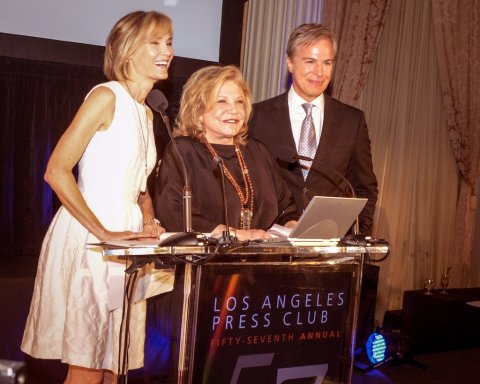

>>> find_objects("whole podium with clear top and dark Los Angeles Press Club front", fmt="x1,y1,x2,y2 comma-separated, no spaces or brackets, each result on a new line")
104,243,388,384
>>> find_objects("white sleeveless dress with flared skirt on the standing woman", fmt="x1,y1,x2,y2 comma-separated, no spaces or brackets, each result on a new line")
21,81,173,372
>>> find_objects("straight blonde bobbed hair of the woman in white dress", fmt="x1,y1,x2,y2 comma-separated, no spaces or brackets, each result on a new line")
103,11,172,80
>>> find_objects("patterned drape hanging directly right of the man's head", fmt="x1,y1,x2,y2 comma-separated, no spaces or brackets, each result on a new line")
323,0,390,105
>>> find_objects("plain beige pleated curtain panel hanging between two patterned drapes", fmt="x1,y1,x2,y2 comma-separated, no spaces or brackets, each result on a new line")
358,0,457,323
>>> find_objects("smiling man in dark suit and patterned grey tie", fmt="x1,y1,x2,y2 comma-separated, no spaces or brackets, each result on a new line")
249,24,378,235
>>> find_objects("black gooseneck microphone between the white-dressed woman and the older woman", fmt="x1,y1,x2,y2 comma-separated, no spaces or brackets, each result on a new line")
147,89,204,245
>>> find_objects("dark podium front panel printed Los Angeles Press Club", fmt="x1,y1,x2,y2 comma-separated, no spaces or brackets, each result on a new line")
185,261,358,384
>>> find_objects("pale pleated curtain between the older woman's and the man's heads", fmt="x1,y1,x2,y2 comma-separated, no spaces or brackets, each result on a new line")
241,0,322,102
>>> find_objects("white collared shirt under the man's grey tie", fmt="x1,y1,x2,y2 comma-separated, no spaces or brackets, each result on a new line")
288,86,325,149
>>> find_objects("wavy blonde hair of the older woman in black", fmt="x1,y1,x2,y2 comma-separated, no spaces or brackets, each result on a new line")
175,65,252,144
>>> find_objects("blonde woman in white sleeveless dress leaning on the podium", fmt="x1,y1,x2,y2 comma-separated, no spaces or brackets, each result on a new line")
22,11,173,384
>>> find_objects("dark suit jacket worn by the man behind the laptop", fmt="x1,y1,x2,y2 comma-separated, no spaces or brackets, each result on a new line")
249,92,378,234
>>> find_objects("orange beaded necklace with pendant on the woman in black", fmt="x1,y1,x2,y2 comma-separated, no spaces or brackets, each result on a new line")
204,140,254,229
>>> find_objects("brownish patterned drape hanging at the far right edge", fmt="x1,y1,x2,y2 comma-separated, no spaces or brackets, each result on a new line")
432,0,480,286
